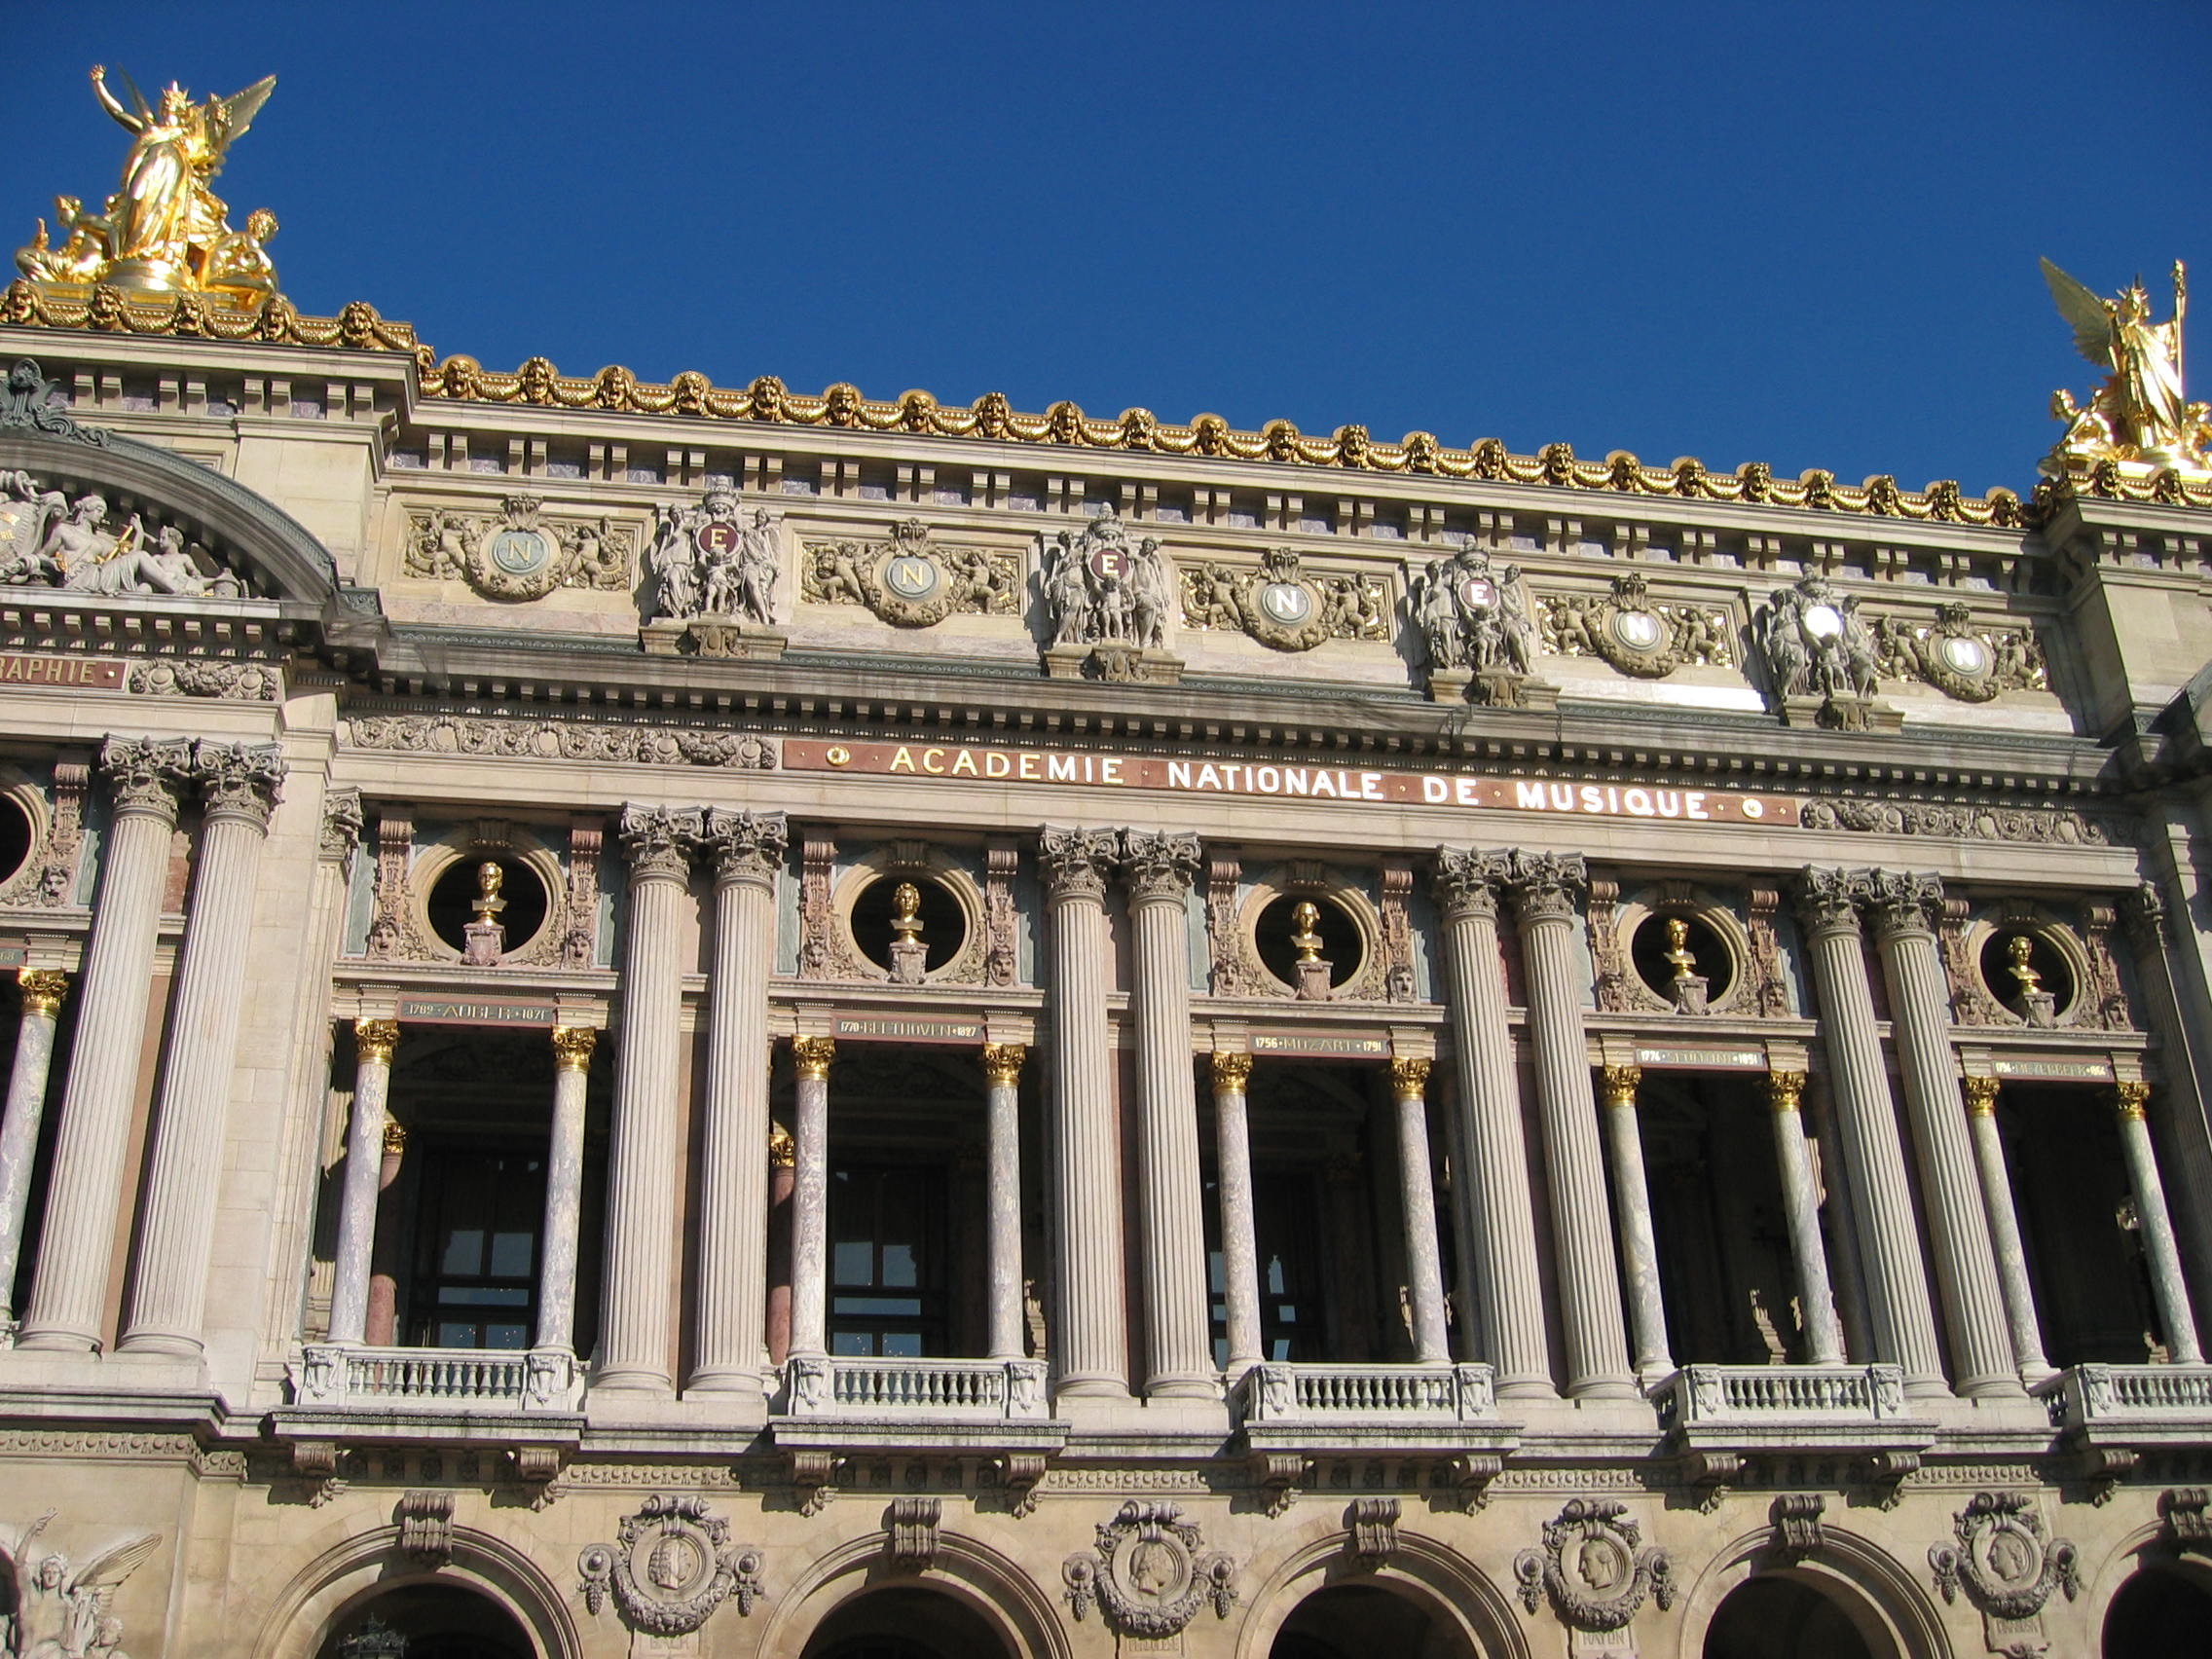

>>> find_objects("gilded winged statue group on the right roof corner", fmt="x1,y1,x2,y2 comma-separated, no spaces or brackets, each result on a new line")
2042,259,2212,471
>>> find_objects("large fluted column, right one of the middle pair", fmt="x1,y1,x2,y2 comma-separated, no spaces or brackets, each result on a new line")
1122,830,1221,1400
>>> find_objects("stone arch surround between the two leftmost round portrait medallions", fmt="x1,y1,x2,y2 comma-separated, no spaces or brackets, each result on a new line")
758,1529,1073,1659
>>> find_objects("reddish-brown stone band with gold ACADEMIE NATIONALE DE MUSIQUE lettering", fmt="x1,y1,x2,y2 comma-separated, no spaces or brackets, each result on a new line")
783,737,1798,825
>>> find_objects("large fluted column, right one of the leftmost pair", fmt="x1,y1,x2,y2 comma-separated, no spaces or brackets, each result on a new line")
117,739,283,1356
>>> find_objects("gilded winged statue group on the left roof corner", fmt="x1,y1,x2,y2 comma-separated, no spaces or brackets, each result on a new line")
16,66,276,306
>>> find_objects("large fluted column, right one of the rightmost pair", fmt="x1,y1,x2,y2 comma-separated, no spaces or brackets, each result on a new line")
1873,869,2019,1396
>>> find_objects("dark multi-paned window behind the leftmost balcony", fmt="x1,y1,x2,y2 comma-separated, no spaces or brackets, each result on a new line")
409,1146,546,1347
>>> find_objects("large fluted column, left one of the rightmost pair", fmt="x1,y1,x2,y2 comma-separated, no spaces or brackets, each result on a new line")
1798,869,1949,1396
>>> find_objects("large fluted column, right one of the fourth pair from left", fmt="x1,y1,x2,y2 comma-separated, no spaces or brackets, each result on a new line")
1506,852,1640,1400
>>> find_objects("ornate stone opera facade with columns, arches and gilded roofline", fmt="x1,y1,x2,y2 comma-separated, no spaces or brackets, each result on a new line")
0,107,2212,1659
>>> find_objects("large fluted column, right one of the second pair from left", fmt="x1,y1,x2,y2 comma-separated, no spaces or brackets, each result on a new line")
685,807,790,1396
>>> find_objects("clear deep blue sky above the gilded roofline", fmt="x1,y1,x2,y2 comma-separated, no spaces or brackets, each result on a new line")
0,0,2212,491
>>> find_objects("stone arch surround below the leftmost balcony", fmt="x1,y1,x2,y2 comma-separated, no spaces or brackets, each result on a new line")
250,1527,584,1659
